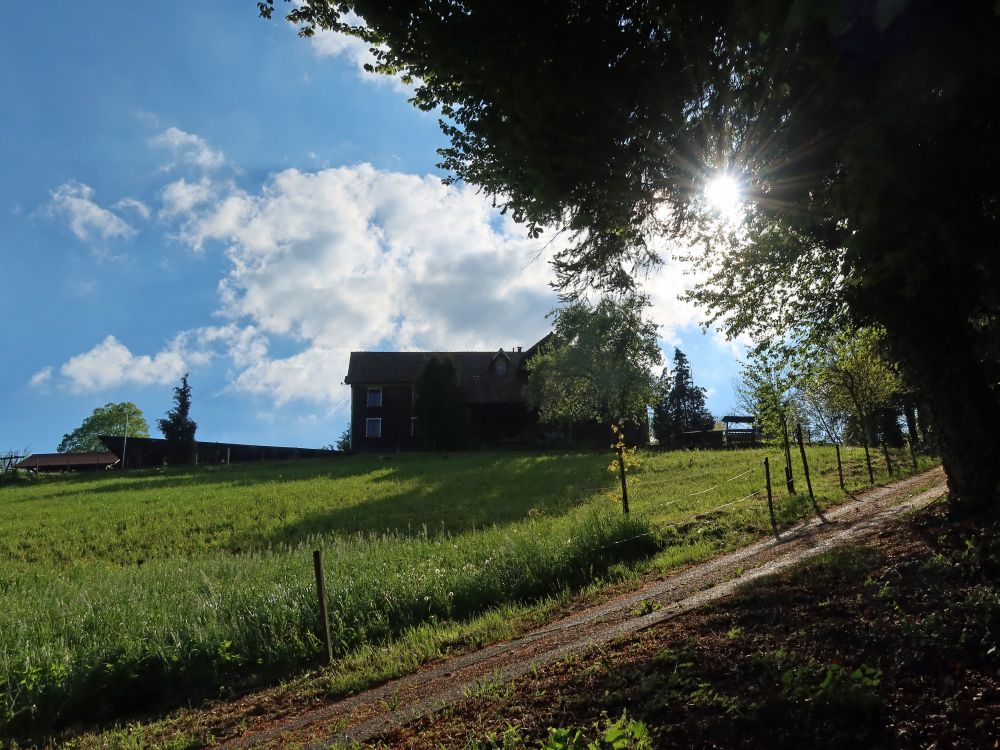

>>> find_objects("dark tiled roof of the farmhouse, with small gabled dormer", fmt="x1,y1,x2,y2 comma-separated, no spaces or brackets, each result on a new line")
344,351,527,404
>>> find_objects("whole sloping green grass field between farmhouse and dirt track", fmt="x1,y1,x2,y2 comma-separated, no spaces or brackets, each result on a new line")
0,447,929,738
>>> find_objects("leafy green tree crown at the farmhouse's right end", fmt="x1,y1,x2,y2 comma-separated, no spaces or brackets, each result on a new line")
525,295,662,432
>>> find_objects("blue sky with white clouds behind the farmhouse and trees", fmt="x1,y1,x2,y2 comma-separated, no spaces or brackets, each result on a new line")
0,2,738,452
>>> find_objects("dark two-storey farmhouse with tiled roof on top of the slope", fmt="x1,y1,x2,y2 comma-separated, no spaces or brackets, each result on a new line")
344,337,547,451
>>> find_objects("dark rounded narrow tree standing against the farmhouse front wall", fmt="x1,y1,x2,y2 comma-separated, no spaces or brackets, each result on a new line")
413,354,465,451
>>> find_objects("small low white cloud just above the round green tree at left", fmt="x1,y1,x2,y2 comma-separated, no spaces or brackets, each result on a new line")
59,336,188,393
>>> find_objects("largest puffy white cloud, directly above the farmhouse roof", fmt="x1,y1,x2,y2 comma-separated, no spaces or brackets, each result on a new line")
178,165,555,401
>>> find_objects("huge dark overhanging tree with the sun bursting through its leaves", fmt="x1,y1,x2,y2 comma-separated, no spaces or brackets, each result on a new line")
258,0,1000,509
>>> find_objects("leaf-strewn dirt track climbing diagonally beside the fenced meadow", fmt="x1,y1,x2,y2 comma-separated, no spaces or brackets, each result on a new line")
222,469,945,748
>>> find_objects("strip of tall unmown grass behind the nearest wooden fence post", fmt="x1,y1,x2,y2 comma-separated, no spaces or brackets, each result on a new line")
0,509,654,733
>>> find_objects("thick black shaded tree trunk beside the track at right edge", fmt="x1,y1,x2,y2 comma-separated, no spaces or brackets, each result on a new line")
890,314,1000,515
